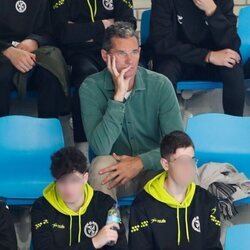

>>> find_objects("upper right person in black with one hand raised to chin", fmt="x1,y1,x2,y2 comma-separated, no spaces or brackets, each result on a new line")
150,0,245,116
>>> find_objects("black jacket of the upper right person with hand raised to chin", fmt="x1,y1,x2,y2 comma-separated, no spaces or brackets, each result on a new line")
150,0,240,65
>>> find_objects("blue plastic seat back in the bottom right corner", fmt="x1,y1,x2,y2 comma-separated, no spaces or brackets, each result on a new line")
225,224,250,250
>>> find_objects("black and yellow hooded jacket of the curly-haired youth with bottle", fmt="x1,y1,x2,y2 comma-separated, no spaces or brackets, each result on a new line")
31,183,127,250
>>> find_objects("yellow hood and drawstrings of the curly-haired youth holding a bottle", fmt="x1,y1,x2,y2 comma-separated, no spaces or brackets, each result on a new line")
43,182,94,246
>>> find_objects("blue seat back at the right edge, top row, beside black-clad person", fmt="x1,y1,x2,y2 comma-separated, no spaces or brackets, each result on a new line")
238,6,250,63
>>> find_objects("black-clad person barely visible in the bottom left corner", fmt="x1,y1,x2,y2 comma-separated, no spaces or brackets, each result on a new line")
0,201,17,250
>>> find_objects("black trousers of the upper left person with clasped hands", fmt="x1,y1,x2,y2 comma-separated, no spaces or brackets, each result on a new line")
0,56,65,118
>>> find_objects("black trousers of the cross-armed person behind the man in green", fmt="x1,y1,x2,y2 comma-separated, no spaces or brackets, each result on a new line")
67,51,106,143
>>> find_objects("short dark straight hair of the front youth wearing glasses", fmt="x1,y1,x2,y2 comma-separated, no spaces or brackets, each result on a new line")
160,131,194,158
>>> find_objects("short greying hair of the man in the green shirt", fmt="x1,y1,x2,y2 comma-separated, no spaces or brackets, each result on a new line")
102,22,139,51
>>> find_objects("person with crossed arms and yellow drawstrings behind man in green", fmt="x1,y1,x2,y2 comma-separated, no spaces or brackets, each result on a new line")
51,0,136,143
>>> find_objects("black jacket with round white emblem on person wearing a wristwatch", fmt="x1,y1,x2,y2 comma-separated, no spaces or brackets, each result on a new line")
0,0,53,52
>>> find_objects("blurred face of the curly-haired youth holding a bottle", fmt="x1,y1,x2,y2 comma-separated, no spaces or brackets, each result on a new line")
56,172,88,203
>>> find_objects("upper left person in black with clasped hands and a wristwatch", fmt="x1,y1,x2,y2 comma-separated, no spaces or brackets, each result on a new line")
0,0,63,118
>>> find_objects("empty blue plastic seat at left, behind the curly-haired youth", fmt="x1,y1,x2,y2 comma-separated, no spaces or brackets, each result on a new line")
0,116,64,204
